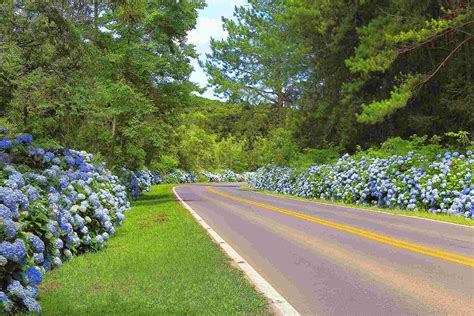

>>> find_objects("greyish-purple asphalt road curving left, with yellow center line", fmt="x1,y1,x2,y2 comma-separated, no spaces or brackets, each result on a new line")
176,184,474,315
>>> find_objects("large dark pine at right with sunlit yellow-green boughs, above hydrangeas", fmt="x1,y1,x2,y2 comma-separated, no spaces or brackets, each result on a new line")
287,0,474,150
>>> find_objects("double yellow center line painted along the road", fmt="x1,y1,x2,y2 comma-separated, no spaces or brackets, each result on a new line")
206,186,474,267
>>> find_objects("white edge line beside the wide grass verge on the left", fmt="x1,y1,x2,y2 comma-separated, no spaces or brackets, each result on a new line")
173,187,300,315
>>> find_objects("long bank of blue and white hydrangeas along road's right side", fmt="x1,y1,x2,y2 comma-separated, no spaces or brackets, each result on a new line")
249,151,474,218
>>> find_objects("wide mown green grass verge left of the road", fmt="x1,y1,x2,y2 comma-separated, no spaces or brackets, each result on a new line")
40,185,269,315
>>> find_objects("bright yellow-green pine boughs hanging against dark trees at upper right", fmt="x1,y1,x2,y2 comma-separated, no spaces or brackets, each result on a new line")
346,3,473,124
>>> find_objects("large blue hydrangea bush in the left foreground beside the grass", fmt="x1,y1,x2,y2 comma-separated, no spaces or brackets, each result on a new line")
0,131,130,313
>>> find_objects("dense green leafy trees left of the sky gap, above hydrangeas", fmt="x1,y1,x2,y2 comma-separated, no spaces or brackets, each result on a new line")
0,0,204,168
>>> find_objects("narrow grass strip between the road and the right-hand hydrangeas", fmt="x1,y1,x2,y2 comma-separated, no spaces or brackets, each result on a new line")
241,186,474,226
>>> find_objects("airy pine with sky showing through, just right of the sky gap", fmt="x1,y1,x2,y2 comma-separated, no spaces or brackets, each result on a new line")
203,0,308,123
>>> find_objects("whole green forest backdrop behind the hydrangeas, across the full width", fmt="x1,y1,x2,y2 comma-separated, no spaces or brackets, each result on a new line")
0,0,474,171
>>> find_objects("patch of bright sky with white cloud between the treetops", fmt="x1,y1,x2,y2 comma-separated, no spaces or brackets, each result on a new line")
188,0,247,99
